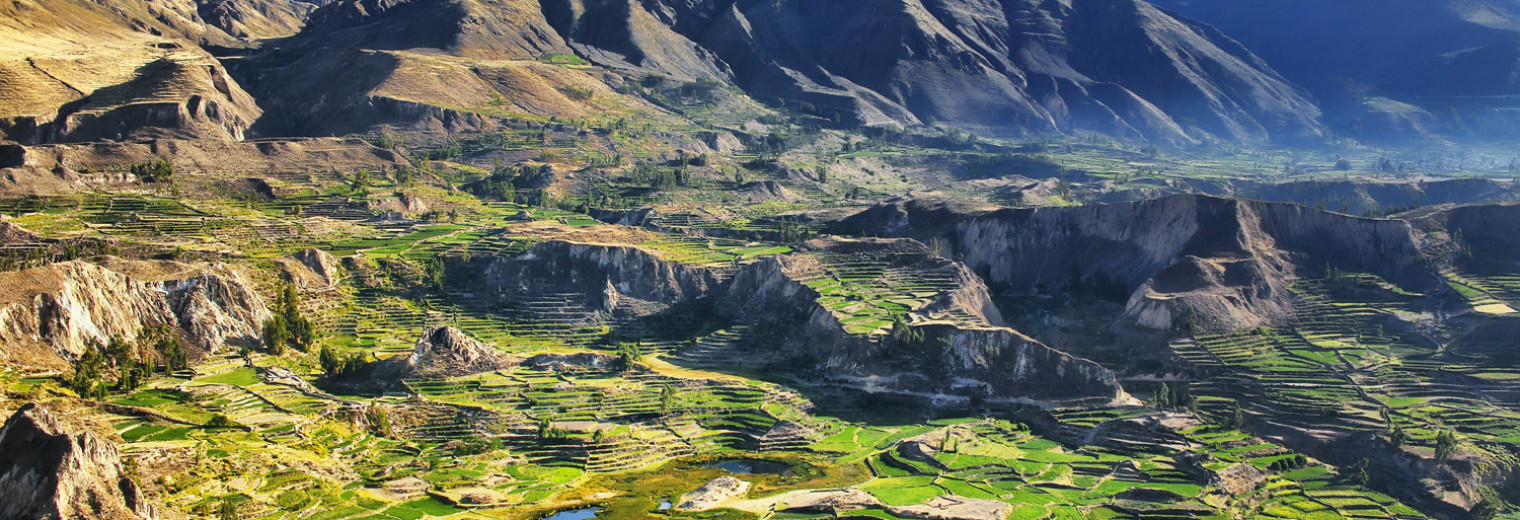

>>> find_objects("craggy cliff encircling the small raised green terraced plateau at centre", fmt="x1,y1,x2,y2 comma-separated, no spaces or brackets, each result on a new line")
725,239,1128,403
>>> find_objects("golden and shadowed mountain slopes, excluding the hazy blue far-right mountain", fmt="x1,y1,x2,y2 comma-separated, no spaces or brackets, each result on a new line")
0,0,1321,144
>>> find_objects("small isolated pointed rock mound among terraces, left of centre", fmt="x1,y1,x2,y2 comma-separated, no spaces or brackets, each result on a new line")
371,327,518,382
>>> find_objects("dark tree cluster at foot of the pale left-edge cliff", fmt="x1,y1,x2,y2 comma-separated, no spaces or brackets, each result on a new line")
61,327,188,398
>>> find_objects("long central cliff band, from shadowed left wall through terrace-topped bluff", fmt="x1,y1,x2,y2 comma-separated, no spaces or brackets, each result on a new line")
449,239,1128,403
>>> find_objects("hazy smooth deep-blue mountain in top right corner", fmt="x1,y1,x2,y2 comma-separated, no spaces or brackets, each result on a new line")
1155,0,1520,137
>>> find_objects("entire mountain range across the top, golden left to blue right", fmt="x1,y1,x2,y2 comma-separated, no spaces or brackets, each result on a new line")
0,0,1520,146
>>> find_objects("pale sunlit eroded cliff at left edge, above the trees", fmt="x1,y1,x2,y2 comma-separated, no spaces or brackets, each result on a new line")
0,262,269,366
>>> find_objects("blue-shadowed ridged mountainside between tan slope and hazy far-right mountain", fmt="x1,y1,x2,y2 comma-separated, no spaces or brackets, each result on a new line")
699,0,1319,143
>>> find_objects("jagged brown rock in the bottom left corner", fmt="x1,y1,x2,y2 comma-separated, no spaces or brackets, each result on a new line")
0,403,158,520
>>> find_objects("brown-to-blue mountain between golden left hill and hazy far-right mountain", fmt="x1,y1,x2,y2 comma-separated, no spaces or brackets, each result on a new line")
245,0,1321,143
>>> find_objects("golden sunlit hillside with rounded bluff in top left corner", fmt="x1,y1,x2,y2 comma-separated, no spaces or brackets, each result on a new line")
0,0,261,143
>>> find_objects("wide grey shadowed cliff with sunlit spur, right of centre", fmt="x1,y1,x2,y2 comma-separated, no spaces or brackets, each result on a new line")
851,195,1439,330
